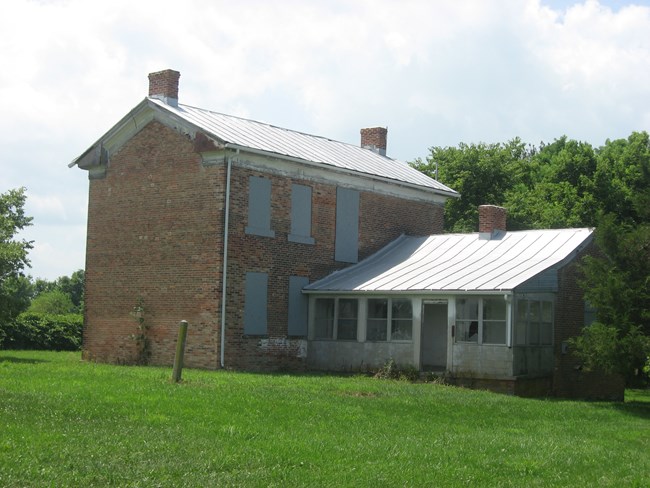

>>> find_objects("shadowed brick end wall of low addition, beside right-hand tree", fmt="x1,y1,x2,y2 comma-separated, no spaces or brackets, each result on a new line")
553,244,625,400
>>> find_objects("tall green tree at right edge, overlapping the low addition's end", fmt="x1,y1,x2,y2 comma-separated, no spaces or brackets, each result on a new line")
574,132,650,381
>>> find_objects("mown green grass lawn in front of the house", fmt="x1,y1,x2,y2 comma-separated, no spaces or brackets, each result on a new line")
0,351,650,487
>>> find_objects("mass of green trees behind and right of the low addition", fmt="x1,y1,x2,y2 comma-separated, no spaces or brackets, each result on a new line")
411,132,650,382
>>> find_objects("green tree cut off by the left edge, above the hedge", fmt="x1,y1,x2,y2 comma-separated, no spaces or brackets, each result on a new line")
0,188,33,324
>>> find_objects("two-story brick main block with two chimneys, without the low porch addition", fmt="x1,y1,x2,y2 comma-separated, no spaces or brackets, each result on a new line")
71,70,458,370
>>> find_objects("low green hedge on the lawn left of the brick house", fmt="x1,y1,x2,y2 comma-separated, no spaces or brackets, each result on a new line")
0,312,83,351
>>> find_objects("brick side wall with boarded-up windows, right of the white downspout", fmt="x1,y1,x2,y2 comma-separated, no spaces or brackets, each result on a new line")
220,168,443,369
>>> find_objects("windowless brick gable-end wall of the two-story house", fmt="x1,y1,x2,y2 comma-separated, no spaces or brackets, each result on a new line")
83,122,224,368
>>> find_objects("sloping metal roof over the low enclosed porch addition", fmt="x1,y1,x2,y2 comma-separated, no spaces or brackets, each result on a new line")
304,229,592,292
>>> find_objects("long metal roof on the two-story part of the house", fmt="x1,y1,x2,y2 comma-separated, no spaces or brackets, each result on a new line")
147,98,458,196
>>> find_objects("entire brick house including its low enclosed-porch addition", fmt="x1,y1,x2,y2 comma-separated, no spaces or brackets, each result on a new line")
71,70,623,398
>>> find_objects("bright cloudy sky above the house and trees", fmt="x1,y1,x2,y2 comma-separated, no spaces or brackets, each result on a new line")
0,0,650,279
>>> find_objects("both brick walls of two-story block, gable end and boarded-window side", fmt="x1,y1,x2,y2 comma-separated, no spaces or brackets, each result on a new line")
84,122,443,370
